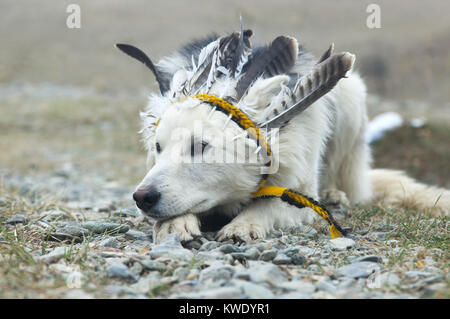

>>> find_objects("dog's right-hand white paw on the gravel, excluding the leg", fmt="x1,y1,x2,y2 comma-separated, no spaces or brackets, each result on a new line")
217,221,266,242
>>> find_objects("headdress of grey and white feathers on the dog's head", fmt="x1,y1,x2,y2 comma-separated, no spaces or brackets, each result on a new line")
116,25,355,136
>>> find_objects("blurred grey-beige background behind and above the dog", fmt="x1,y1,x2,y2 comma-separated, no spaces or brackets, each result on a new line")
0,0,450,187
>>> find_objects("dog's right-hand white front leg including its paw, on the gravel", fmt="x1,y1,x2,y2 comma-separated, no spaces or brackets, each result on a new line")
218,198,318,242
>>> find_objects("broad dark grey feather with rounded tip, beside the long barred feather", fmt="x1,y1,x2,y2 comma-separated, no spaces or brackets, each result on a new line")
236,36,298,100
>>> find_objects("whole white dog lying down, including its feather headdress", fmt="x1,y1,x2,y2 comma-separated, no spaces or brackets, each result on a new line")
118,30,450,242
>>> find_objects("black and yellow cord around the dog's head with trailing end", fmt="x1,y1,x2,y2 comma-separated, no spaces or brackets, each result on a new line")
155,94,345,238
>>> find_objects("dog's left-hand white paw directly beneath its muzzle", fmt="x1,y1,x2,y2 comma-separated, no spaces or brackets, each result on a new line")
153,214,202,244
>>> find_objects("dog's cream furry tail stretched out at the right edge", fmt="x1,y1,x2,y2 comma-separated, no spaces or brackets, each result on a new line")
370,169,450,216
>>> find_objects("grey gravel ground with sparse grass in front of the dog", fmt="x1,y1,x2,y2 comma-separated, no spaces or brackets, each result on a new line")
0,167,449,298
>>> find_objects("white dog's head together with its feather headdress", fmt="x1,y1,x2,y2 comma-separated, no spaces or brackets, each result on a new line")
117,29,354,219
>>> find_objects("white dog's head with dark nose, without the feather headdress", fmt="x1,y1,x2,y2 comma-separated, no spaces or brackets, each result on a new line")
133,98,261,219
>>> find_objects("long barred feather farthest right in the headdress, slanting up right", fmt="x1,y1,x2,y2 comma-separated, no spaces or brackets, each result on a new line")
259,52,355,129
